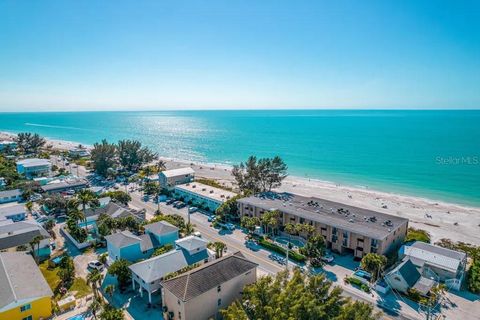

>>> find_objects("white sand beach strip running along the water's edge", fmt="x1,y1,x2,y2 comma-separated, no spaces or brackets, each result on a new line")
0,132,480,245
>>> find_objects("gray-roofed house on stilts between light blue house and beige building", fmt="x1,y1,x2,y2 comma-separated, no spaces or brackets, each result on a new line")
129,236,214,303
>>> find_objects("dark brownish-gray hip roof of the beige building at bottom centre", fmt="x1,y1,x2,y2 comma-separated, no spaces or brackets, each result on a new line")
163,252,258,301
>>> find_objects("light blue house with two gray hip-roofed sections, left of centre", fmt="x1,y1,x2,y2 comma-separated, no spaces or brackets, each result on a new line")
105,221,178,262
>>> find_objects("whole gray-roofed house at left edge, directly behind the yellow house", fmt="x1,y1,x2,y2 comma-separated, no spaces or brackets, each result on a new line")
0,219,51,260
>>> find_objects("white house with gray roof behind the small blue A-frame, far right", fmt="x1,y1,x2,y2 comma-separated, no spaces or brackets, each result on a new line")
398,241,467,290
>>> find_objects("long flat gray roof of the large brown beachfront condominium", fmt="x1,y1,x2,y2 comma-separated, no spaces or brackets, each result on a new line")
237,192,408,240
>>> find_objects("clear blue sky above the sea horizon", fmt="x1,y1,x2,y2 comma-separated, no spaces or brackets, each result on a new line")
0,0,480,111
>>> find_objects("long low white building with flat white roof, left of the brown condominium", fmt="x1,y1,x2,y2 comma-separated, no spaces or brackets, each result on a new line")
175,182,237,212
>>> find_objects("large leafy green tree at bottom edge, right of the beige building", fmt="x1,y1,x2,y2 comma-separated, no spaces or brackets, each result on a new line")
221,269,379,320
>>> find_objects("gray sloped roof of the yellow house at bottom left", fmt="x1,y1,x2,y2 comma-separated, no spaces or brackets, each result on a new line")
0,252,53,308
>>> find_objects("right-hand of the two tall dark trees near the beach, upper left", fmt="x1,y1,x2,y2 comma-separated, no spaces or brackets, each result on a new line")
117,140,158,172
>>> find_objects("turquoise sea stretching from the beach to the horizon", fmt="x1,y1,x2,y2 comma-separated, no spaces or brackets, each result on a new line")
0,110,480,205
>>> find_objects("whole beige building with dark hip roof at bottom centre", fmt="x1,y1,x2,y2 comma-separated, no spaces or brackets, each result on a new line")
162,252,258,320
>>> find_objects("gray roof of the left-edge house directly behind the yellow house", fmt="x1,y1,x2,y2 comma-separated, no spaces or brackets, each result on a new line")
0,221,50,250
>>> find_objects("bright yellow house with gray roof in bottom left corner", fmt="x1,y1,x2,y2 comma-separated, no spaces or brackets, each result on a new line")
0,252,53,320
